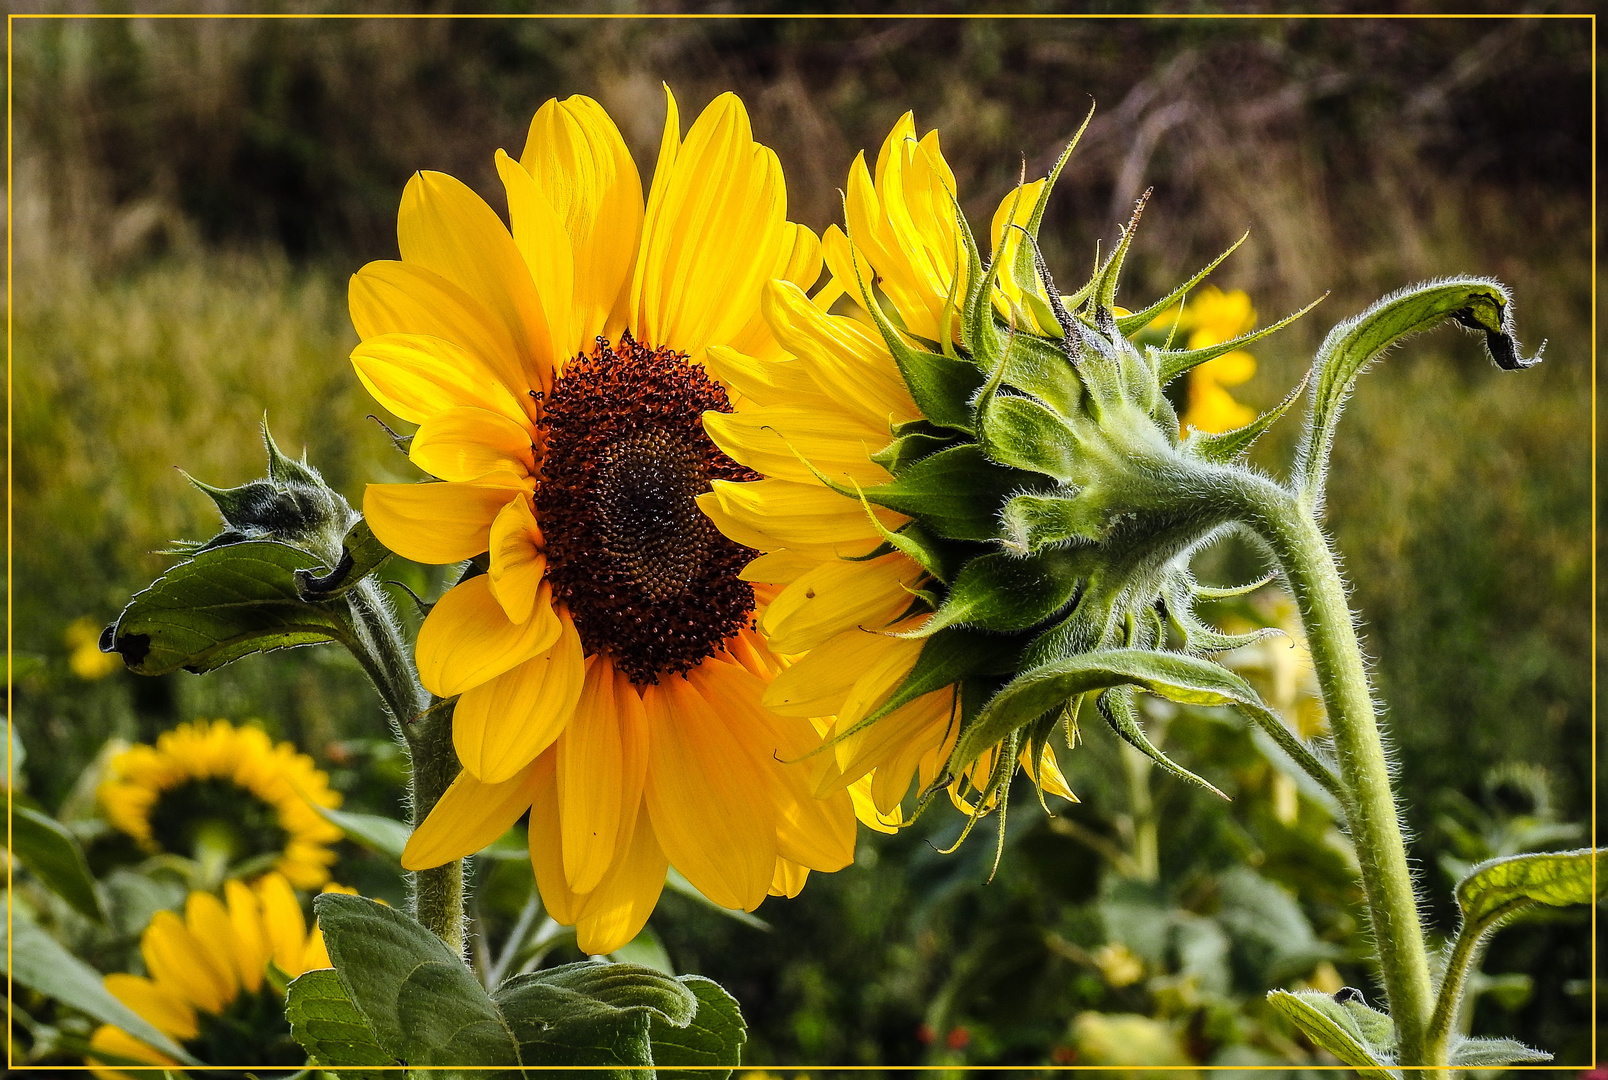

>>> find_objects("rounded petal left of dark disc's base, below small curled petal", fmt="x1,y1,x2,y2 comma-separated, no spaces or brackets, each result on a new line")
415,574,561,700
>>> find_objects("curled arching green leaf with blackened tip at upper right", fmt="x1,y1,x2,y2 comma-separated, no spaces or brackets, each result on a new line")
1296,278,1545,500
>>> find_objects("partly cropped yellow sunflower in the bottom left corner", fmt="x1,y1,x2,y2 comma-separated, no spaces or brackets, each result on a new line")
90,873,357,1078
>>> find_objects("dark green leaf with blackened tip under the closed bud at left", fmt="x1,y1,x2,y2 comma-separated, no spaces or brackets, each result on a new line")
101,540,351,675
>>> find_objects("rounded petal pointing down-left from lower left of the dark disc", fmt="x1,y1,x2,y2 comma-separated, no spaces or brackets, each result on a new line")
453,604,585,784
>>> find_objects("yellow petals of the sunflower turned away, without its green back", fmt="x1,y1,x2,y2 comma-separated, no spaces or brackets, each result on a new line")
698,114,1073,820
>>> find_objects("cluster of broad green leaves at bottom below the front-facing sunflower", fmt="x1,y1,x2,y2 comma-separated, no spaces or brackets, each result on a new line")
310,894,745,1077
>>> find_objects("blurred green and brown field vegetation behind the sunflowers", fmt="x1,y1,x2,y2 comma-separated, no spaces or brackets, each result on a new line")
11,5,1594,1066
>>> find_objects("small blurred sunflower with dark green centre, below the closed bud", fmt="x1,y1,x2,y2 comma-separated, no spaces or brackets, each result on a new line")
100,720,341,889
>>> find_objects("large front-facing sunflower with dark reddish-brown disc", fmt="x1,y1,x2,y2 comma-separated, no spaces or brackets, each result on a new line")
351,93,854,953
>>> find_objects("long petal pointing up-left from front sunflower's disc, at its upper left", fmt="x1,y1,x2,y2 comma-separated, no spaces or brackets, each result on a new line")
397,172,563,391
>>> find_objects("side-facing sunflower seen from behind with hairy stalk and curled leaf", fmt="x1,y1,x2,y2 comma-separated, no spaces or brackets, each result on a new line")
701,116,1534,1064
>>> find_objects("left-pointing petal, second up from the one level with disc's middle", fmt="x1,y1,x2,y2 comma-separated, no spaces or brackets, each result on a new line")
352,334,531,424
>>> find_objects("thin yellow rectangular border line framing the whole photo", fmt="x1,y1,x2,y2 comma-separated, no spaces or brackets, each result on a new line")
5,11,1598,1072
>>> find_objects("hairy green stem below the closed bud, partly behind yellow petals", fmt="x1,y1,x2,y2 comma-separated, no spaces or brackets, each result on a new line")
346,580,466,955
